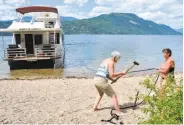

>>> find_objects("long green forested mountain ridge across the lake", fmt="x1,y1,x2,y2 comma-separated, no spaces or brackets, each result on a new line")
0,13,182,35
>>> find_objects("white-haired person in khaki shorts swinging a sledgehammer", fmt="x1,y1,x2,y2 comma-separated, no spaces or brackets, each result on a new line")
93,51,138,116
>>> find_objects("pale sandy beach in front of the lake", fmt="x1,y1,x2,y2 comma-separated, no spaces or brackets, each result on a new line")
0,74,182,124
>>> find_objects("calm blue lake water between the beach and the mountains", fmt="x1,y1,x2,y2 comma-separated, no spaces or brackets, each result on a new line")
0,35,183,77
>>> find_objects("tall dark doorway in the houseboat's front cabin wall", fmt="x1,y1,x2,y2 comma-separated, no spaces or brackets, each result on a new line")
25,34,34,54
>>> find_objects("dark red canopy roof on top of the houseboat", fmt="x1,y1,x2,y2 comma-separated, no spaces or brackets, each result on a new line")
16,6,58,14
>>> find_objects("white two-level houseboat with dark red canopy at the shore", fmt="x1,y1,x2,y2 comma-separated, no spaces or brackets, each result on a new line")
1,6,65,70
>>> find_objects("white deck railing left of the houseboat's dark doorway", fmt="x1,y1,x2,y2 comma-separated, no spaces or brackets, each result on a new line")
4,48,27,59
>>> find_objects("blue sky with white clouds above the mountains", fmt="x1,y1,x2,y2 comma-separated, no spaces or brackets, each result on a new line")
0,0,183,29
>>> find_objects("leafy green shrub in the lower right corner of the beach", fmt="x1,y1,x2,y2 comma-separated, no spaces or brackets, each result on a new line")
141,74,183,124
